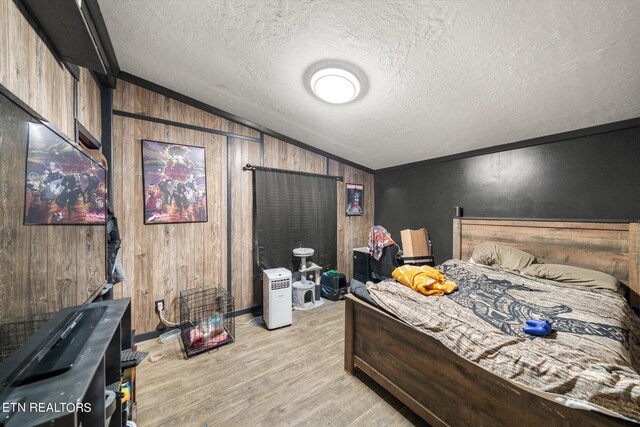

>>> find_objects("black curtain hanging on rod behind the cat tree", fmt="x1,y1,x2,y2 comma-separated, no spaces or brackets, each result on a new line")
254,170,337,288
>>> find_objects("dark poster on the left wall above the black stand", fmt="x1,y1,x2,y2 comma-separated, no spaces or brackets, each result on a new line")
24,122,107,225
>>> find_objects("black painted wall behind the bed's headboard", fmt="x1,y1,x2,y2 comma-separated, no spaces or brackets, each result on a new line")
375,119,640,263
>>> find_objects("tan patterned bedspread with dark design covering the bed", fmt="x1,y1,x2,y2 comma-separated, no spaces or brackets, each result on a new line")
367,260,640,422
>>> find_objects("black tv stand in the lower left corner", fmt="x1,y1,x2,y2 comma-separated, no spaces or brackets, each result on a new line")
0,298,132,427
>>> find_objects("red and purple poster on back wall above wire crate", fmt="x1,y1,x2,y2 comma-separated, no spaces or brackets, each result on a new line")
142,140,207,224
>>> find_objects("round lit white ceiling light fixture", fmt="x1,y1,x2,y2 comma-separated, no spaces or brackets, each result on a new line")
309,65,362,104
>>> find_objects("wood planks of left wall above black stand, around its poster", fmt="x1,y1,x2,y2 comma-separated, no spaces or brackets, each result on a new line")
0,0,105,322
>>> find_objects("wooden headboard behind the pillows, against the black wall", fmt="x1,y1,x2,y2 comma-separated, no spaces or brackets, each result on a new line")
453,218,640,307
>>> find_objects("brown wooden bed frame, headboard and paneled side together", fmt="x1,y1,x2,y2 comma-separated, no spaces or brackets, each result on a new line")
344,218,640,427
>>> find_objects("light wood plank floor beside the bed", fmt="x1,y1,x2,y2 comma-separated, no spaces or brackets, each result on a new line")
137,300,422,427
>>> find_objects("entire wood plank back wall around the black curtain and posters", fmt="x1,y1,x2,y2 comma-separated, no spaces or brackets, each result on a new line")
112,81,373,333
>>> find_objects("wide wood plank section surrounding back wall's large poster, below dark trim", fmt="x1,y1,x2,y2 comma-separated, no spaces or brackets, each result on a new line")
111,116,227,331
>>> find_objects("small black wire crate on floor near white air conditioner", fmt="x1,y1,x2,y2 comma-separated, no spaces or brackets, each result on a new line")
180,288,236,358
